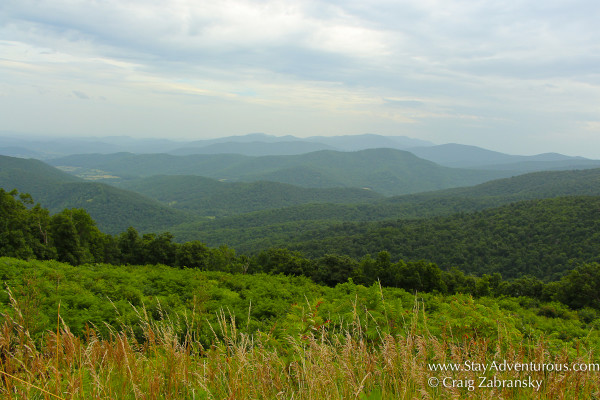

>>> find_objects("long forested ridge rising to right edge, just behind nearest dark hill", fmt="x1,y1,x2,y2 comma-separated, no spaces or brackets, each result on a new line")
170,169,600,245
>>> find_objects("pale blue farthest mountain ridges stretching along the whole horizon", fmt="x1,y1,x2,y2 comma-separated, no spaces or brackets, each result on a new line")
0,132,600,173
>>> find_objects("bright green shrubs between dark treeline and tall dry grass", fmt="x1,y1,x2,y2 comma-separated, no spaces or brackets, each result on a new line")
0,258,600,349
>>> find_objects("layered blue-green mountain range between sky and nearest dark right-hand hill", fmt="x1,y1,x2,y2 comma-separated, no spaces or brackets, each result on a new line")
0,134,600,244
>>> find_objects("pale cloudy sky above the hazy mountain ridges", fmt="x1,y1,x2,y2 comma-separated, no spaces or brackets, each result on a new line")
0,0,600,159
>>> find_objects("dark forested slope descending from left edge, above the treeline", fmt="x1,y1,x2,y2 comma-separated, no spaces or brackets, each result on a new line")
0,156,190,234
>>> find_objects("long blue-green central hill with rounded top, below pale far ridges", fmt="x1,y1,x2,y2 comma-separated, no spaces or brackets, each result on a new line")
51,149,509,195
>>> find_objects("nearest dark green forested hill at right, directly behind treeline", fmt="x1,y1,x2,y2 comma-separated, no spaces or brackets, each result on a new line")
284,196,600,279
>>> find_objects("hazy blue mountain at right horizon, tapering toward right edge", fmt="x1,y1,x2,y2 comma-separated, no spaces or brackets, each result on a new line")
408,143,600,172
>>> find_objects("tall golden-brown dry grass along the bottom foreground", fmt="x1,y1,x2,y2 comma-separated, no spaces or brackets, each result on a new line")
0,296,600,400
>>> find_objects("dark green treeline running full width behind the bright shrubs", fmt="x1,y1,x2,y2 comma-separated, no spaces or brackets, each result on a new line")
0,189,600,310
